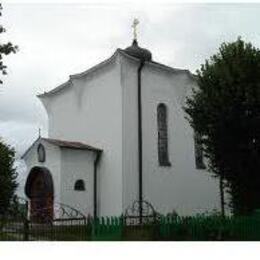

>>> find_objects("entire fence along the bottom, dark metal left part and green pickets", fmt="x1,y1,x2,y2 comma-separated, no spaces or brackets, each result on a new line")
3,212,260,241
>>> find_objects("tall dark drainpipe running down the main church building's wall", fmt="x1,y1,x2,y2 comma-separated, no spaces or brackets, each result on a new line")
137,60,144,223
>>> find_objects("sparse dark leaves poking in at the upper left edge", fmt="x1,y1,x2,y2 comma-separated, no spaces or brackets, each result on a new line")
0,3,18,84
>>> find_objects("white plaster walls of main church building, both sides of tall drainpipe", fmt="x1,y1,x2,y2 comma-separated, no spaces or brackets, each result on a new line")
34,49,223,216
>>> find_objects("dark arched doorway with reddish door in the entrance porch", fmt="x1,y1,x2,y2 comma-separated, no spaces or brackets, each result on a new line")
25,166,54,222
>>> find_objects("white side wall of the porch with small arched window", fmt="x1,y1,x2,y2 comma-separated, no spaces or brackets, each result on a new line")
61,148,96,216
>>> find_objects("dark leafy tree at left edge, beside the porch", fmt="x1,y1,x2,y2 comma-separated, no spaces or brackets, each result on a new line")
0,141,17,214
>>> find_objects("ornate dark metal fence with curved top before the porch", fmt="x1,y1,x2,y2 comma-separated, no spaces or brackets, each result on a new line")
0,198,91,241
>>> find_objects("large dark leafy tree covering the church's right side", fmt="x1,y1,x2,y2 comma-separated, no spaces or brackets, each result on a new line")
184,37,260,214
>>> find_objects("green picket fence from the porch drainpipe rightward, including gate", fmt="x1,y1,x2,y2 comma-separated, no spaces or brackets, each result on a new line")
91,213,260,241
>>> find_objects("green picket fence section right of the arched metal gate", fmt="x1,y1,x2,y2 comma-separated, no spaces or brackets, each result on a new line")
159,216,260,241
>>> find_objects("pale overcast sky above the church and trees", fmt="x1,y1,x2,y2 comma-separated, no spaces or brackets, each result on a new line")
0,1,260,193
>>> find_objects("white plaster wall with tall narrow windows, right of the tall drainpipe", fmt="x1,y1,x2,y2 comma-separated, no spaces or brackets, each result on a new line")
142,65,220,215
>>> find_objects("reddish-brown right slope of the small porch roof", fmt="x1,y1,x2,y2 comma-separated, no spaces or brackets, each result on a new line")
41,138,102,152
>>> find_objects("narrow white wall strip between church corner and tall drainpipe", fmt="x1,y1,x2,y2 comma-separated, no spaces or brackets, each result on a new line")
121,56,139,211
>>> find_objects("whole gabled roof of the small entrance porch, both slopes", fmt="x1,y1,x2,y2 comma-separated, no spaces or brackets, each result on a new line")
21,137,102,159
